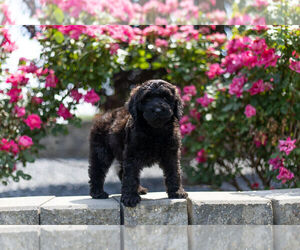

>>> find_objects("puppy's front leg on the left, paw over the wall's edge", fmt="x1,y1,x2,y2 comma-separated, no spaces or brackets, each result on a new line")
121,159,141,207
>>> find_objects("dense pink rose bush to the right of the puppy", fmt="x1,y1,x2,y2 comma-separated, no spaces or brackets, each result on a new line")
181,26,300,190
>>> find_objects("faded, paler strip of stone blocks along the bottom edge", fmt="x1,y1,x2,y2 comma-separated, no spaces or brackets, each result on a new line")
0,225,300,250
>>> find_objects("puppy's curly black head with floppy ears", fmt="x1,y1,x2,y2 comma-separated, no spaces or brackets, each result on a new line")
127,80,183,128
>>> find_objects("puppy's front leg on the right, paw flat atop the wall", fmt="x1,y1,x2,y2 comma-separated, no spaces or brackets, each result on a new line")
160,152,188,199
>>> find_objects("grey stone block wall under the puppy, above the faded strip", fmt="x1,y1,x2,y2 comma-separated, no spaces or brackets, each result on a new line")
0,189,300,226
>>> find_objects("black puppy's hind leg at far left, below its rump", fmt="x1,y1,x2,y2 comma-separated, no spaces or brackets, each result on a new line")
89,133,114,199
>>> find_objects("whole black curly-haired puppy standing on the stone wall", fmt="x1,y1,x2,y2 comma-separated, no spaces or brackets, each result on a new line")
89,80,187,207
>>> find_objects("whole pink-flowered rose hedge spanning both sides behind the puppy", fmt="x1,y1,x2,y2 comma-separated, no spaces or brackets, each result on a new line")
0,24,300,189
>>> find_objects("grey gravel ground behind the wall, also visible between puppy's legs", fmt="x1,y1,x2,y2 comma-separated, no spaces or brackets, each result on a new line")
0,159,210,197
